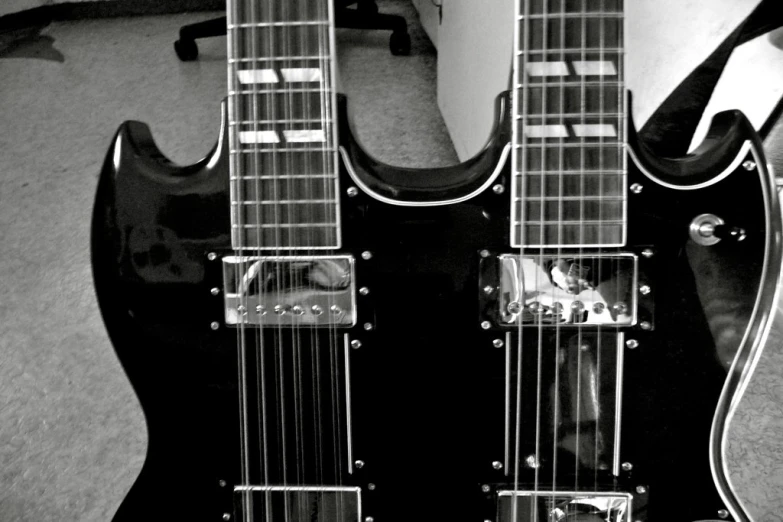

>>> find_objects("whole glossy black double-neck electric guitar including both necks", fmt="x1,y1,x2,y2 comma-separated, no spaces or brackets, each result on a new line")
92,0,781,522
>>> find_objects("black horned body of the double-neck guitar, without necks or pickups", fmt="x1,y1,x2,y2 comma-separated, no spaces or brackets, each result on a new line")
92,84,781,522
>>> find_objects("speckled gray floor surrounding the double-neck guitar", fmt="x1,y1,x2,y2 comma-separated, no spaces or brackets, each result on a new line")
0,0,783,522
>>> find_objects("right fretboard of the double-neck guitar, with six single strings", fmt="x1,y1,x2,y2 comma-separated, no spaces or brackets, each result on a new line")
511,0,626,247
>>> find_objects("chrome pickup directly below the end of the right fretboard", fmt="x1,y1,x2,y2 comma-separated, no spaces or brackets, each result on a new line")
480,253,649,326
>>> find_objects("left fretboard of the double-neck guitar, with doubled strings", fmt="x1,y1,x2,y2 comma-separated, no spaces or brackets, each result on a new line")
227,0,340,250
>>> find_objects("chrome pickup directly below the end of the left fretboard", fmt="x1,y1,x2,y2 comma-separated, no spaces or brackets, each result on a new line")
223,255,356,327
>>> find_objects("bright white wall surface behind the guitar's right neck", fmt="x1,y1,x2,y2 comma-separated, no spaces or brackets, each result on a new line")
434,0,783,160
